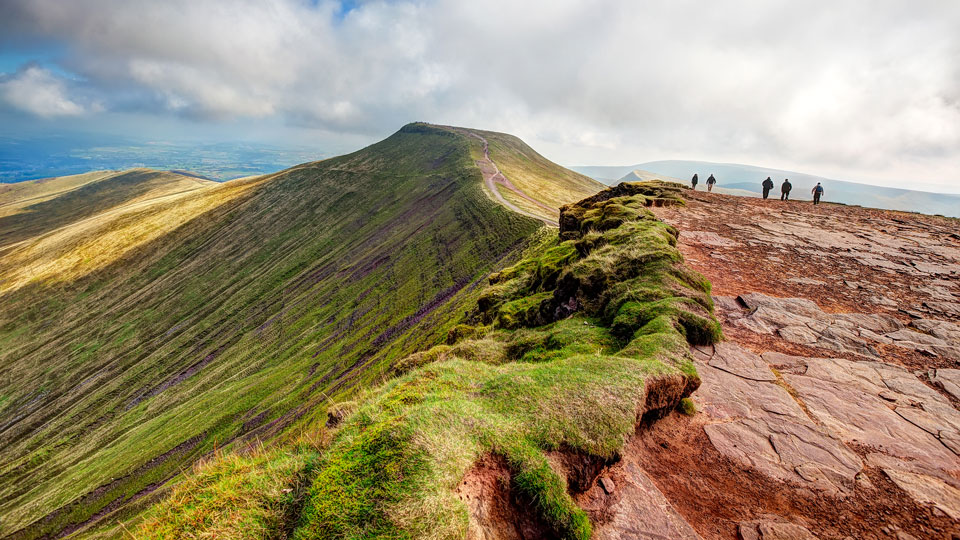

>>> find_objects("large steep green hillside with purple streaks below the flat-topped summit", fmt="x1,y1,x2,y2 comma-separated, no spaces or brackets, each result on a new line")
0,124,584,538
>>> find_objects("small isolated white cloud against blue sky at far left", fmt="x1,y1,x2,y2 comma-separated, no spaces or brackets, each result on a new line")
0,65,87,118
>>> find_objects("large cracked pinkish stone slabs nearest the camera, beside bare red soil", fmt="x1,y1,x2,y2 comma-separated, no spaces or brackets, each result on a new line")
693,343,960,519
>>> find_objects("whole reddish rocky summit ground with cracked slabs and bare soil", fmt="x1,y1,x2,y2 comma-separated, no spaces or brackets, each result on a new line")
581,192,960,540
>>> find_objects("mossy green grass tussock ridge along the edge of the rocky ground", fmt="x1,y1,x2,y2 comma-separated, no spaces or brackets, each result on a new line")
295,182,722,539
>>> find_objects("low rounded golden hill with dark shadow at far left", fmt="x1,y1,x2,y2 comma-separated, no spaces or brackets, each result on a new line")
0,169,217,252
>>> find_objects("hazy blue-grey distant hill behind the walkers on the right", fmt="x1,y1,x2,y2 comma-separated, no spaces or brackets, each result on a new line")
571,160,960,217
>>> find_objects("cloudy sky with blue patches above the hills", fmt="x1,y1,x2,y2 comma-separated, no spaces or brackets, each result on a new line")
0,0,960,192
